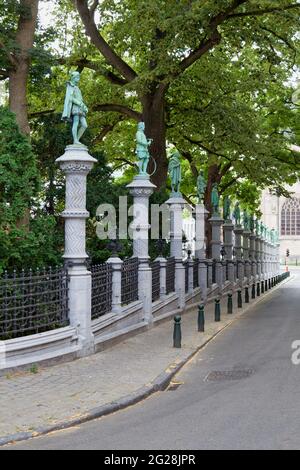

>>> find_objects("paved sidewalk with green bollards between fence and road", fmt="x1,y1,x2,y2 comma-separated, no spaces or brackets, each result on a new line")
0,281,286,445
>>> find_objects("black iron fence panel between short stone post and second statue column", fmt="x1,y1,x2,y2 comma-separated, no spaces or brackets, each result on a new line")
121,258,139,305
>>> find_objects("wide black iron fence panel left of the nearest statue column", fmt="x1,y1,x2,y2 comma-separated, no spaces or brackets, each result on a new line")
0,268,69,340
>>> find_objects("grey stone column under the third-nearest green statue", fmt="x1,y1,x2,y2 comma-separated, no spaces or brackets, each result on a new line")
166,196,186,308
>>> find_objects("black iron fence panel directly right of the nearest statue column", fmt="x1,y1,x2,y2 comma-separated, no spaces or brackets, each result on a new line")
91,263,112,320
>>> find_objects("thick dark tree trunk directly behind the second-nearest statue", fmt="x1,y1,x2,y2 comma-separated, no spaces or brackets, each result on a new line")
141,94,168,189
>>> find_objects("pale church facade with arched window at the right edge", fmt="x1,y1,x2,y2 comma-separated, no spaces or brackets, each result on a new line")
261,182,300,265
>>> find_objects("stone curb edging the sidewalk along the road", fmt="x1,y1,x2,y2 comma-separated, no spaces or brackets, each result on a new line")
0,276,294,447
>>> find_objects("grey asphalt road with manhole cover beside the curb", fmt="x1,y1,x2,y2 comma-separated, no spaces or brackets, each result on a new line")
7,275,300,450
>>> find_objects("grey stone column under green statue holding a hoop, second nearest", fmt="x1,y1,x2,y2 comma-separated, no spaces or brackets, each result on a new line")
126,176,156,323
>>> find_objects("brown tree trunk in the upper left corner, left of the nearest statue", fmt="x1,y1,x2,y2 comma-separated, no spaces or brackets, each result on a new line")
9,0,39,135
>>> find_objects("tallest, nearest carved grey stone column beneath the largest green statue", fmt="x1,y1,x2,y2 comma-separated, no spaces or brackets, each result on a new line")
56,144,97,356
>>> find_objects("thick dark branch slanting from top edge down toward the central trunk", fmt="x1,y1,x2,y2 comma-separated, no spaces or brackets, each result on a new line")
74,0,137,82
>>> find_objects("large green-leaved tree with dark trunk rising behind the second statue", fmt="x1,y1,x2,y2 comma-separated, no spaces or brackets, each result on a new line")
73,0,300,187
